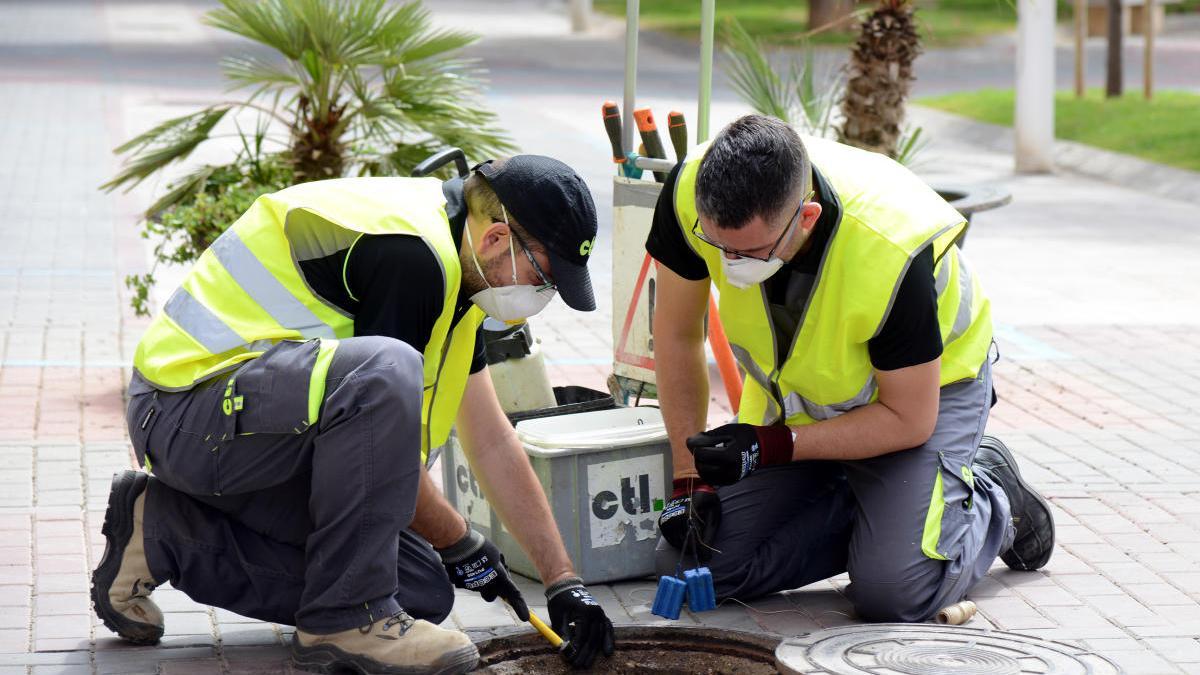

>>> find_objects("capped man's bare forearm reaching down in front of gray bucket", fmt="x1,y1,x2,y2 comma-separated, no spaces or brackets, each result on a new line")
470,428,575,586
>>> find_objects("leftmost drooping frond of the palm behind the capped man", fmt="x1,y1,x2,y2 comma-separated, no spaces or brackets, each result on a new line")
100,106,232,192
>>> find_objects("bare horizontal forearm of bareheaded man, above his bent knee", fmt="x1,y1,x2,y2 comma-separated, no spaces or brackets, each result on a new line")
792,402,929,460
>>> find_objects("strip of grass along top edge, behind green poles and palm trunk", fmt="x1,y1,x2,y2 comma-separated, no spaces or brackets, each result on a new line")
594,0,1016,46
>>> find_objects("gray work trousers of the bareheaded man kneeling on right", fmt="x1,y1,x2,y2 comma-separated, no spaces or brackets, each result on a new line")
655,364,1014,621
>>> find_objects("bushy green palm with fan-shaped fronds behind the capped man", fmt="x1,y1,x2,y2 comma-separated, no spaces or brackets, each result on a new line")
102,0,512,205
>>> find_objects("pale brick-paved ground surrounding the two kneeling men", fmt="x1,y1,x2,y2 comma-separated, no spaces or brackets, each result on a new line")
0,0,1200,675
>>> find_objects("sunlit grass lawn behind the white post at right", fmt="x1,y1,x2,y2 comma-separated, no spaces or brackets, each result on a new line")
916,89,1200,171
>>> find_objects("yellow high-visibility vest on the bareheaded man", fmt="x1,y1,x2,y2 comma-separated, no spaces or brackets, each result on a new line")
674,138,991,424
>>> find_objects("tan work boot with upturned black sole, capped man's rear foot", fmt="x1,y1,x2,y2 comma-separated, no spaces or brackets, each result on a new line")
91,471,163,645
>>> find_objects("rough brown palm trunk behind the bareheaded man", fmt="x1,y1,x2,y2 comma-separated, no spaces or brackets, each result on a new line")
838,0,920,157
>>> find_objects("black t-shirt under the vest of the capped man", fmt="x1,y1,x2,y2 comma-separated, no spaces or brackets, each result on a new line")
300,181,487,372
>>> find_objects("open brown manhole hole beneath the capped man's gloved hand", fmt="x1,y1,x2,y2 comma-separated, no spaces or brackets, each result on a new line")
475,626,779,675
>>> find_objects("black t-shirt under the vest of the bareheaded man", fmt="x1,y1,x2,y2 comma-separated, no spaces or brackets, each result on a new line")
646,166,942,370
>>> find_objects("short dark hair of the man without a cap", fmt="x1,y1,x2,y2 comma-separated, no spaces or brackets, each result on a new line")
689,115,812,229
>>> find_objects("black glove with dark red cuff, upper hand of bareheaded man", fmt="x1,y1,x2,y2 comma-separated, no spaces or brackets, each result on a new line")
688,424,792,485
